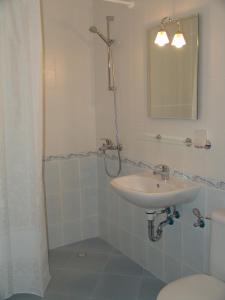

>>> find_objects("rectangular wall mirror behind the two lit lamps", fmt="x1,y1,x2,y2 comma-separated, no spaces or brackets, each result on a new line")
148,16,198,120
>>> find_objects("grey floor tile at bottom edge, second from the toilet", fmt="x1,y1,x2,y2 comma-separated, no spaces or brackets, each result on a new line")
92,274,140,300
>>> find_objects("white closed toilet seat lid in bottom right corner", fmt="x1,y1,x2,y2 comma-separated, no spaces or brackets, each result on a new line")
157,274,225,300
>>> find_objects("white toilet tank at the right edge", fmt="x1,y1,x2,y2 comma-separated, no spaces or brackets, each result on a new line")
209,209,225,281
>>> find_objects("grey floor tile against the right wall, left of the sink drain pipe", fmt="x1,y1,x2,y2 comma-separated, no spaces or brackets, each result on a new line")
105,255,143,276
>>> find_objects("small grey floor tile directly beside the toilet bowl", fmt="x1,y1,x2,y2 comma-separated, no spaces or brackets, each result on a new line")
138,278,165,300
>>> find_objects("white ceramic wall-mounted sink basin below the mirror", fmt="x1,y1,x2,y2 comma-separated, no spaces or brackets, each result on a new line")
111,172,200,209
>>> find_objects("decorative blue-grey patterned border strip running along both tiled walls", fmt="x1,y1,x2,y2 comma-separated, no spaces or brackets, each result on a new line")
43,151,225,191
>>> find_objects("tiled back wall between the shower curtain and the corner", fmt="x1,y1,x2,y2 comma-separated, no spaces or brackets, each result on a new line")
42,0,98,248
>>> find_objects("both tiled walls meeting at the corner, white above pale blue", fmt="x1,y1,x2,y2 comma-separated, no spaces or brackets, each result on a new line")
43,0,225,281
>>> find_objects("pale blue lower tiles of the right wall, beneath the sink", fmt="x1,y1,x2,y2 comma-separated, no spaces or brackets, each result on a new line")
98,158,225,282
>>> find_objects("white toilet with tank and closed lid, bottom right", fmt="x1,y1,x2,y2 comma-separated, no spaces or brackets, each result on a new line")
157,209,225,300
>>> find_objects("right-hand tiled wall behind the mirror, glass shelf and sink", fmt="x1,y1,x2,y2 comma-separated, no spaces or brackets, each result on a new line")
94,0,225,281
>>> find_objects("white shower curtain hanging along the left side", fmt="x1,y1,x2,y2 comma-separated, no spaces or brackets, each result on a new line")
0,0,49,299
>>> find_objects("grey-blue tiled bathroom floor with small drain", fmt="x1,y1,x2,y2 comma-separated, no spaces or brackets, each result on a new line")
10,238,164,300
